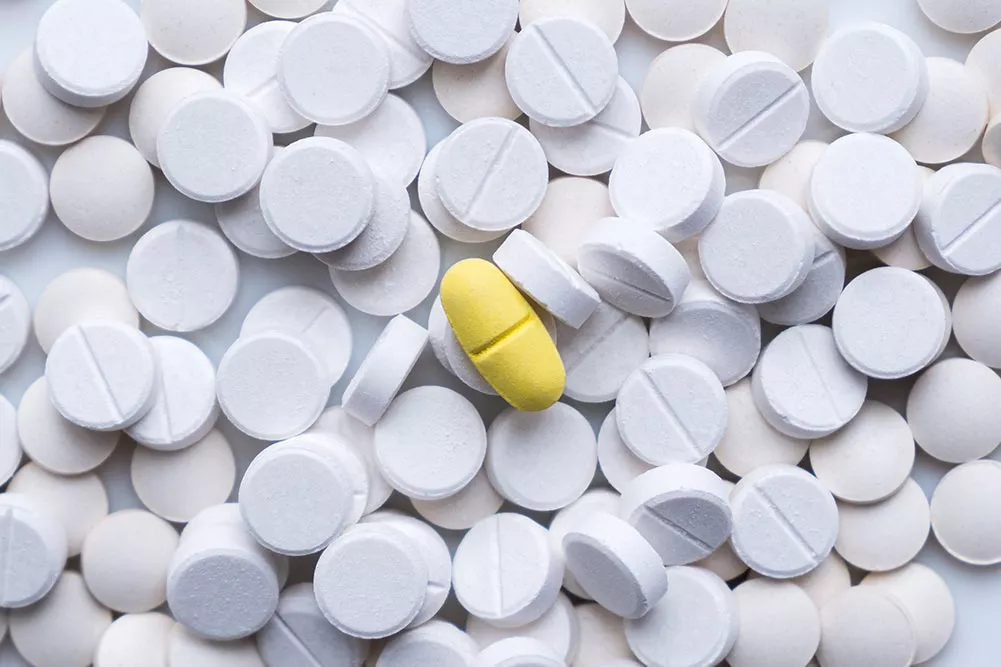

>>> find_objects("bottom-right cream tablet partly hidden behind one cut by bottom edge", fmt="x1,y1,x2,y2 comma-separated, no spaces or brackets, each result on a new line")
861,563,956,664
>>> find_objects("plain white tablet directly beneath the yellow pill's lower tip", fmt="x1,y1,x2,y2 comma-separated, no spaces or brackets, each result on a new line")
486,403,598,512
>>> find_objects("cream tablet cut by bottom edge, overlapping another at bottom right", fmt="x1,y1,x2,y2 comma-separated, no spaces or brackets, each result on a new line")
817,586,917,667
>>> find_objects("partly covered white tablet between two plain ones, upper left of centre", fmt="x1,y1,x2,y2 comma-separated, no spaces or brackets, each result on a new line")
316,93,427,187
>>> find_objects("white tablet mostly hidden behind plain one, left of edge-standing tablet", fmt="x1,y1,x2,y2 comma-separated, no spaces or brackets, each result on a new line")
240,285,353,386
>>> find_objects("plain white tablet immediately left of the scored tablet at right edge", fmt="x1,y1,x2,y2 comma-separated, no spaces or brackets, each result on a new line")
810,134,923,249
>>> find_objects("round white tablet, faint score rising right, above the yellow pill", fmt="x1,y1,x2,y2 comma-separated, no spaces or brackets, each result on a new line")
435,118,549,231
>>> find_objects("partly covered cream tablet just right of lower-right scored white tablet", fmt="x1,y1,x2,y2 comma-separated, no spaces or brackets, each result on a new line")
835,479,931,572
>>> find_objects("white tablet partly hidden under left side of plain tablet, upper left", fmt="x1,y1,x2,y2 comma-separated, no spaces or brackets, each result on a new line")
222,21,309,133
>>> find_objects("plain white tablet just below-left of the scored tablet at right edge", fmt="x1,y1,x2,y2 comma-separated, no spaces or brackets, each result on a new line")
833,266,952,380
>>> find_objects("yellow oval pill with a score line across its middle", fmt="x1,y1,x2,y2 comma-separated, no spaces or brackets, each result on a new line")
441,259,567,412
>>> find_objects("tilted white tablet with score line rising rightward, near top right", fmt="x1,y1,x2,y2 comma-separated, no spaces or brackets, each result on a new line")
693,51,810,167
